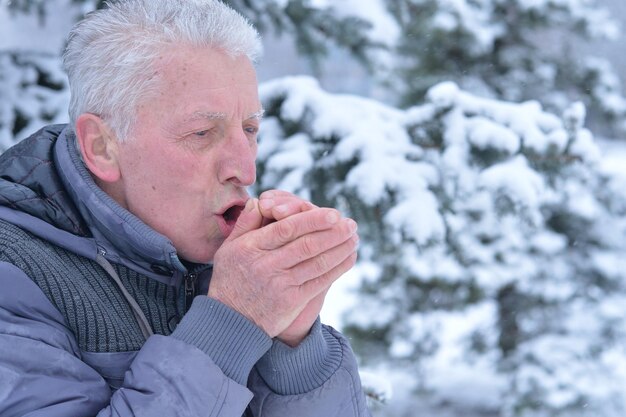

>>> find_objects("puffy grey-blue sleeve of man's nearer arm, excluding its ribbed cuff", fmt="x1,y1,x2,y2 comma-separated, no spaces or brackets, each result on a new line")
0,262,256,417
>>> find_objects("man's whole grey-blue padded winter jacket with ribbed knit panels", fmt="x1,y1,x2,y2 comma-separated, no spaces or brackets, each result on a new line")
0,125,370,417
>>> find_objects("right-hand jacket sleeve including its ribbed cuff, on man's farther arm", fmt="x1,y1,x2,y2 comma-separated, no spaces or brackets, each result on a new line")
248,319,371,417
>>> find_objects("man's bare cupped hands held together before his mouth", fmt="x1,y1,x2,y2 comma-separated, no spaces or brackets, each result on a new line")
208,190,358,346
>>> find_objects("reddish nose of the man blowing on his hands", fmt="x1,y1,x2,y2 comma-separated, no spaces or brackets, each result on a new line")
218,126,257,187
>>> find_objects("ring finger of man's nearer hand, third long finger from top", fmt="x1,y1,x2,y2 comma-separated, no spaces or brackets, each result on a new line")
288,231,359,285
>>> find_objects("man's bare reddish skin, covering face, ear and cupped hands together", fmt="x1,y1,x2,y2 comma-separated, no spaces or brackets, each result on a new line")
76,47,358,346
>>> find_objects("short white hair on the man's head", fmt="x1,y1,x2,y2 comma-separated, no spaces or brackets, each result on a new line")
63,0,262,140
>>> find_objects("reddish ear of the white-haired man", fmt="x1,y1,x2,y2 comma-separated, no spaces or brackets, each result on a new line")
75,113,121,182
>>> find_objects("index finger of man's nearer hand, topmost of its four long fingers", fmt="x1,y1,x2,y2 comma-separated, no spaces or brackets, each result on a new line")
257,208,341,250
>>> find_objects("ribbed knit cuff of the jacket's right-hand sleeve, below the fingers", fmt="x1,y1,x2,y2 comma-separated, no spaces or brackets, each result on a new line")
256,319,343,395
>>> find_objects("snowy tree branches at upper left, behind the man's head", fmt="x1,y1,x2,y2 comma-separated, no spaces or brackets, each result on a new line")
0,0,100,148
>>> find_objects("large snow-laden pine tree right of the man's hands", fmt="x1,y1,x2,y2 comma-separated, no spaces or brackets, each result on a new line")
259,78,626,417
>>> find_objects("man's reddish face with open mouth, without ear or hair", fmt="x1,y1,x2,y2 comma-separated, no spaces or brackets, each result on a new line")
117,44,261,263
